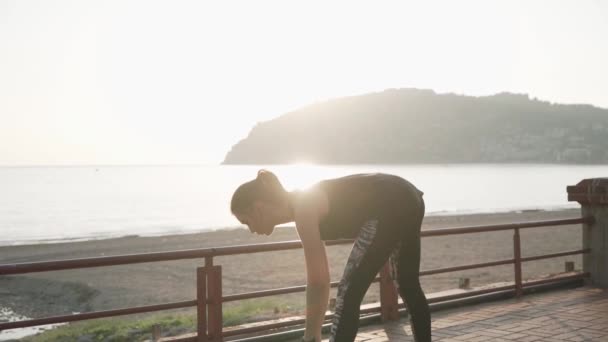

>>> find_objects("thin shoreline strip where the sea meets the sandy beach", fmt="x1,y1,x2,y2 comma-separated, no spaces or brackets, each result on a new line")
0,205,577,248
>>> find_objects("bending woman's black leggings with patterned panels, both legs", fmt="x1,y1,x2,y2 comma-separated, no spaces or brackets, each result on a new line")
330,197,431,342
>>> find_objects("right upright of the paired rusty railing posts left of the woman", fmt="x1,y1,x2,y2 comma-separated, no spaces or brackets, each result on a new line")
207,266,223,342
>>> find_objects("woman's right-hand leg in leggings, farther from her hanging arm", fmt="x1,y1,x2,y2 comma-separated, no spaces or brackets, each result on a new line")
391,200,431,342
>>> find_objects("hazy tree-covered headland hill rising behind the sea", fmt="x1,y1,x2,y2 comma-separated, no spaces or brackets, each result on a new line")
223,88,608,164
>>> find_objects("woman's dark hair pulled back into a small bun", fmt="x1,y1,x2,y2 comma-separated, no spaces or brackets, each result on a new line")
230,170,285,214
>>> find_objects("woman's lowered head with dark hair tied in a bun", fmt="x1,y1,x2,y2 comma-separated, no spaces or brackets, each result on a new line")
230,170,288,235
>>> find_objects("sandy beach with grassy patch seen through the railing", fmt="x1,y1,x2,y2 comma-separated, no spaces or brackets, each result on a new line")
0,209,582,317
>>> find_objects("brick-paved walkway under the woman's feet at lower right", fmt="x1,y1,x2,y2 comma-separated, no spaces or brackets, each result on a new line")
356,287,608,342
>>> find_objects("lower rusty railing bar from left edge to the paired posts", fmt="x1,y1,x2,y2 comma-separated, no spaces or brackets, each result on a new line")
0,300,197,330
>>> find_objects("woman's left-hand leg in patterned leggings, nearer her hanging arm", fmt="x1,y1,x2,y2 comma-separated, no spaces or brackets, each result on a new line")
329,220,397,342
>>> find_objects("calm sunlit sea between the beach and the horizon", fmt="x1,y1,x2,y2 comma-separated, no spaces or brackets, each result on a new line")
0,164,608,246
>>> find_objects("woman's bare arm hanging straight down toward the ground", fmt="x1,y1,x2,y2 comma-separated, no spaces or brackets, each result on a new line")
295,194,330,341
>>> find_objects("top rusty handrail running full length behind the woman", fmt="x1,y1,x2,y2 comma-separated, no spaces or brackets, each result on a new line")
0,216,593,275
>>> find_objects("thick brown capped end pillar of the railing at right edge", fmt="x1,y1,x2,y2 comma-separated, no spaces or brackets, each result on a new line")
566,178,608,289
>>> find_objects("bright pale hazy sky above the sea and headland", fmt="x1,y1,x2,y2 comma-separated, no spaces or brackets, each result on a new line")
0,0,608,166
